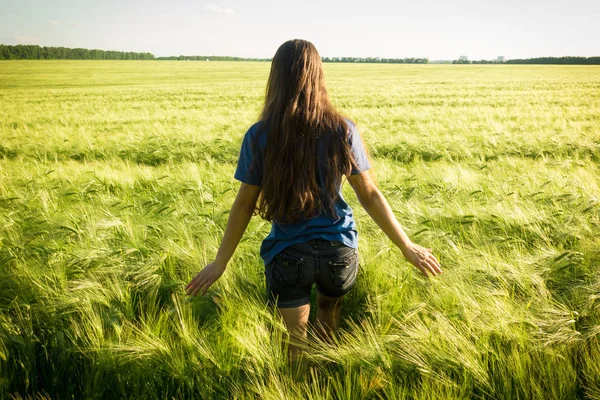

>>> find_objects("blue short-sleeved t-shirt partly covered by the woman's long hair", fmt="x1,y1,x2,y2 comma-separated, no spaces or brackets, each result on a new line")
234,121,371,265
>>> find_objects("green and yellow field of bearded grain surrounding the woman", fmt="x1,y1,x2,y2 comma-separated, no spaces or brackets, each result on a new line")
0,61,600,399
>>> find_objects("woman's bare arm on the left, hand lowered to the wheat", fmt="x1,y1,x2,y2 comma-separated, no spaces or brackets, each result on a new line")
185,183,261,296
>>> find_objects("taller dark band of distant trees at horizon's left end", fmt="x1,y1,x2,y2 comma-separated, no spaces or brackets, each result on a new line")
0,44,154,60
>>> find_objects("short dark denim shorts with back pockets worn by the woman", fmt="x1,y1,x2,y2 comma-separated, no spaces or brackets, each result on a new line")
265,239,358,308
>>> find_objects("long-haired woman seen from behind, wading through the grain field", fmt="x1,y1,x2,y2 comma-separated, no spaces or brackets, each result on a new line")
186,40,442,354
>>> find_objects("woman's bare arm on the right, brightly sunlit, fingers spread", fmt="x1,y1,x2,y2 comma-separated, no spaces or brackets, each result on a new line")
348,171,442,277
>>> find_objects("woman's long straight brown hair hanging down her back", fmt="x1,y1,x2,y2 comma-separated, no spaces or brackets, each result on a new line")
258,39,356,223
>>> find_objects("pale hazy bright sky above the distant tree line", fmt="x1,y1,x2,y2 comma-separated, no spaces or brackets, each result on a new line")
0,0,600,60
